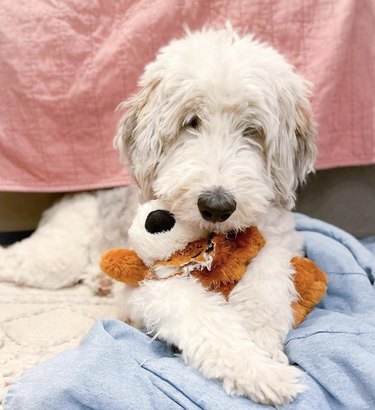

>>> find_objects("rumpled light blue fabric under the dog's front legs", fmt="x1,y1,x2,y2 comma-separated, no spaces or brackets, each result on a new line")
4,214,375,410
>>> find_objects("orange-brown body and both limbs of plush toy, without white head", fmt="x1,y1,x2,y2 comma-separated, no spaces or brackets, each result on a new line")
100,227,327,326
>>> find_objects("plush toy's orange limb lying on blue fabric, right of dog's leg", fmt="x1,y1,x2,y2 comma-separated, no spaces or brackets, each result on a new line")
292,257,327,327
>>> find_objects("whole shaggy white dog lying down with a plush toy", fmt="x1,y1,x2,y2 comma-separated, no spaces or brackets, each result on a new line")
0,27,316,405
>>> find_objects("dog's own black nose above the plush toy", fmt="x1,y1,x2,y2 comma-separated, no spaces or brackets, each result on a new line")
198,187,237,222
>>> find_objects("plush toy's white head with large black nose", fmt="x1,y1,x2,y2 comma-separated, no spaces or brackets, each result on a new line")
129,200,205,266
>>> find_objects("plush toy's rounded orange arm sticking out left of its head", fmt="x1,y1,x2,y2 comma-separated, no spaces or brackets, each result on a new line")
100,249,148,286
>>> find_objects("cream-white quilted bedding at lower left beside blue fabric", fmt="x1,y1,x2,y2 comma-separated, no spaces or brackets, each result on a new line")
0,283,115,408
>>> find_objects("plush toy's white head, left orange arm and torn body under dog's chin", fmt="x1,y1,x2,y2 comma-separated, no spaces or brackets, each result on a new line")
101,200,264,297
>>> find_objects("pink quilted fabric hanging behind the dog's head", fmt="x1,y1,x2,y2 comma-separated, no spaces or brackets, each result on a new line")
0,0,375,191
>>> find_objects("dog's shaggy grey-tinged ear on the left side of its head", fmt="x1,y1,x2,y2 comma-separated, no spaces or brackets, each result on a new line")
114,80,161,199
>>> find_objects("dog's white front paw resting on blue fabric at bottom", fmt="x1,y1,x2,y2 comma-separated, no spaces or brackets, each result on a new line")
223,360,305,406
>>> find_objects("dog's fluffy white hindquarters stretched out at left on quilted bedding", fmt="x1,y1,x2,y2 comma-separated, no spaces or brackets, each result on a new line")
0,193,101,289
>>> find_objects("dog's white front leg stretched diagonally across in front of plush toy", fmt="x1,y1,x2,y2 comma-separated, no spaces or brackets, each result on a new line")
130,277,303,405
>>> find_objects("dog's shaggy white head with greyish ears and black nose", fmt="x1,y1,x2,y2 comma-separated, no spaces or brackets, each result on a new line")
115,28,316,231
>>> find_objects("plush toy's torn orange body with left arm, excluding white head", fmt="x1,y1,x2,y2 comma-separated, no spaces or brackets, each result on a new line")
101,227,264,298
